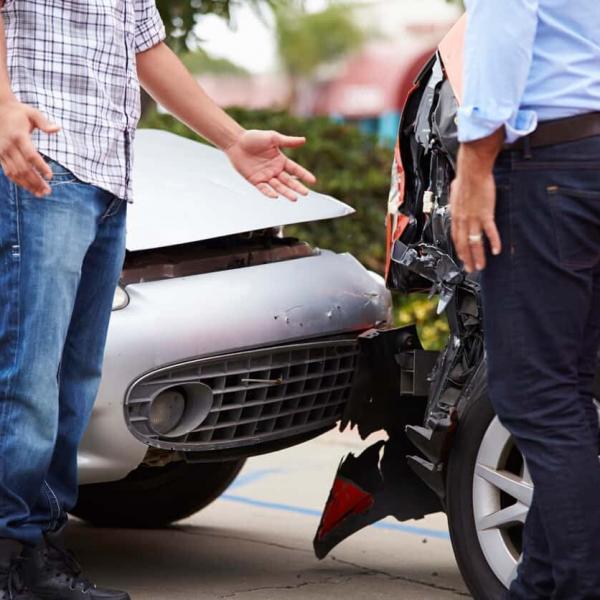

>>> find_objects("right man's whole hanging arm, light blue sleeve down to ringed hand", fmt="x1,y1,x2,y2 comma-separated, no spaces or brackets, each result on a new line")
451,0,539,271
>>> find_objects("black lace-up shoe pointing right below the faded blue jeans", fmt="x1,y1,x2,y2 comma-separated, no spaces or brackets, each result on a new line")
23,531,130,600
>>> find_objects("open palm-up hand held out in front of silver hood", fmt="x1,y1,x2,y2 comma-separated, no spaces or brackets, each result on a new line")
225,130,316,202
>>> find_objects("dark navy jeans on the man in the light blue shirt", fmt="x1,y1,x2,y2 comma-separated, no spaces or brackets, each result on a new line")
482,137,600,600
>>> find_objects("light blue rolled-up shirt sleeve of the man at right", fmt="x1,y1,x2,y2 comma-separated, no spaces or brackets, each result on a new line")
458,0,539,143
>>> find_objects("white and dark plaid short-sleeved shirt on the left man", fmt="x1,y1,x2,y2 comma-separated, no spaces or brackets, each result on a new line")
0,0,165,200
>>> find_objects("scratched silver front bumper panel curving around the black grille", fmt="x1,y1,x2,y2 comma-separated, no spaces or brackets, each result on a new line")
79,251,391,484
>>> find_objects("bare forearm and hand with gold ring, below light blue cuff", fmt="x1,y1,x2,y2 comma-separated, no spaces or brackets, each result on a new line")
450,129,504,273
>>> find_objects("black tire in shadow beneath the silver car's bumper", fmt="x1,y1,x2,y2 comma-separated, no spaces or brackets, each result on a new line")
72,459,246,528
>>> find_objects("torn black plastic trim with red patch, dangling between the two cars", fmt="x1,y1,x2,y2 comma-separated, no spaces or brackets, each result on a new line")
313,325,441,558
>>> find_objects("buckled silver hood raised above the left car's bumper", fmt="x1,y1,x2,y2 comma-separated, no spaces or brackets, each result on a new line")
127,129,354,251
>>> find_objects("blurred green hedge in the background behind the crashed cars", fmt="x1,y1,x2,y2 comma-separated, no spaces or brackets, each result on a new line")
142,109,448,349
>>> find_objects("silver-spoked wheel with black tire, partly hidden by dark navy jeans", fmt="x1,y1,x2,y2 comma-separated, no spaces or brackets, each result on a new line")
446,396,533,600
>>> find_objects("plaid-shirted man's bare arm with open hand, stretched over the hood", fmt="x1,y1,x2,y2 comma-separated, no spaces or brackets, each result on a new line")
137,43,315,200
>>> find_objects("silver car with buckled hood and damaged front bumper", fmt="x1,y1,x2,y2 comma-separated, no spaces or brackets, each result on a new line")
74,130,391,527
